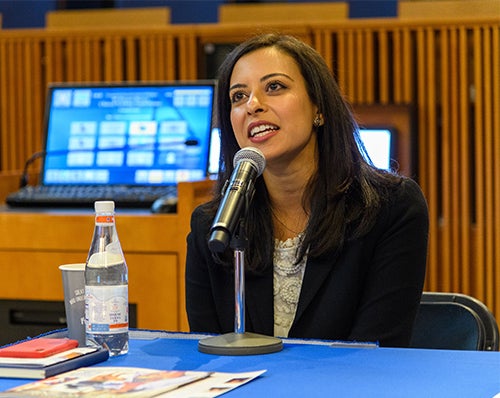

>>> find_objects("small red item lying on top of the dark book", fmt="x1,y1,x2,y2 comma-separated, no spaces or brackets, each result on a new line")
0,337,78,358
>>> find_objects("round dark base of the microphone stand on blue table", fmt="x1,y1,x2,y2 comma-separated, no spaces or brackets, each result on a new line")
198,332,283,355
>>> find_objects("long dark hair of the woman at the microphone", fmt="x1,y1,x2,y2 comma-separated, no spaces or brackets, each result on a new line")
206,33,400,272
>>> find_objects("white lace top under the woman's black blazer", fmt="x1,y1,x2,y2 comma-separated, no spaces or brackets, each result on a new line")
274,234,306,337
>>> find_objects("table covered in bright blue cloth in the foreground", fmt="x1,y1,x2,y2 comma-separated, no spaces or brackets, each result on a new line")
0,331,500,398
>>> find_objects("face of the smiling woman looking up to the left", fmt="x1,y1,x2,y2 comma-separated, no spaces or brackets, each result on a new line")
229,47,317,171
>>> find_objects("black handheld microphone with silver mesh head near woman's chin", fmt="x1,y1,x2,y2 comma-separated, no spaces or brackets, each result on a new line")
208,147,266,253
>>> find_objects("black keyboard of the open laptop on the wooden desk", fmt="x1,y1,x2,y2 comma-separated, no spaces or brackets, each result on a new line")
6,185,177,208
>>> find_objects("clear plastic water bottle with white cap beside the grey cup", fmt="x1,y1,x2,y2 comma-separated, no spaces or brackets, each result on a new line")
85,201,129,356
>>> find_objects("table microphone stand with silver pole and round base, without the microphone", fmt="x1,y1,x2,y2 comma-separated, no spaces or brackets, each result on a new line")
198,218,283,355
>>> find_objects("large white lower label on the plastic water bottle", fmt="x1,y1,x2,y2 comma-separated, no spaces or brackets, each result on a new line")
85,285,128,334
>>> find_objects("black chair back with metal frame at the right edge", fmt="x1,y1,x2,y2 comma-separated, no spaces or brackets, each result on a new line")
410,292,500,351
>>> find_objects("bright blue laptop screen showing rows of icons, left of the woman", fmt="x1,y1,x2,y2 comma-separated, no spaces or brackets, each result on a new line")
42,81,215,185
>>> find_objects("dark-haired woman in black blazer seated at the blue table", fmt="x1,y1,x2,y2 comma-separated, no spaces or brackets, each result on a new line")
186,34,428,347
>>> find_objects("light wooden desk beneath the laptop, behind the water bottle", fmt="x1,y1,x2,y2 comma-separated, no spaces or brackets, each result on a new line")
0,181,213,331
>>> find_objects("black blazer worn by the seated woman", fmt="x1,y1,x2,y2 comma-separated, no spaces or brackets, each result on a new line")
185,179,429,347
